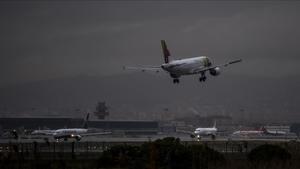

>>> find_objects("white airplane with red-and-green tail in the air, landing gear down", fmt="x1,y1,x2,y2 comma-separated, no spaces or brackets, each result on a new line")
123,40,242,84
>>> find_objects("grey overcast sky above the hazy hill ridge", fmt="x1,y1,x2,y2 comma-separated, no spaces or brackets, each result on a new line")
0,1,300,86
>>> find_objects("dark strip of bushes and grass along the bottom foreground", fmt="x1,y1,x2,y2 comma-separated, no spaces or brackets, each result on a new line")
0,137,300,169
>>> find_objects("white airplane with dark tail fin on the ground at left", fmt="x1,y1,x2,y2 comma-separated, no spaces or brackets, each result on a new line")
31,114,111,141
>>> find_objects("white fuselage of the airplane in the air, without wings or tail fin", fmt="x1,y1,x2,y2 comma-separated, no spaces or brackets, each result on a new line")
161,56,211,76
